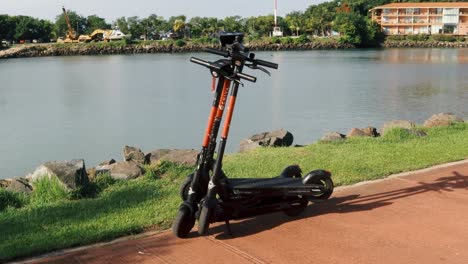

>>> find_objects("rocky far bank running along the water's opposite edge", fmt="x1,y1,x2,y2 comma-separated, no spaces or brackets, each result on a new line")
0,40,468,59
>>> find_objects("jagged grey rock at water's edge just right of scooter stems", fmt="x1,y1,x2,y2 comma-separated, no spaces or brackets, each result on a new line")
239,128,294,152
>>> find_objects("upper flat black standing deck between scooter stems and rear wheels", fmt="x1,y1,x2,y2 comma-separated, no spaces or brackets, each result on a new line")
228,178,311,190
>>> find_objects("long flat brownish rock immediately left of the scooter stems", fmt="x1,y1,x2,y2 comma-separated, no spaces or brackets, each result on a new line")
145,149,198,166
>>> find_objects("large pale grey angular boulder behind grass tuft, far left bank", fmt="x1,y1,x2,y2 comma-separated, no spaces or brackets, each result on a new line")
27,159,89,190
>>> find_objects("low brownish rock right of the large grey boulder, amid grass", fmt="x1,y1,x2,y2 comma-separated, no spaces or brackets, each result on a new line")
96,161,143,180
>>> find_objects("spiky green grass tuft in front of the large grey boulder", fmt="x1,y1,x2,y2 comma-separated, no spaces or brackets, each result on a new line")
30,177,70,206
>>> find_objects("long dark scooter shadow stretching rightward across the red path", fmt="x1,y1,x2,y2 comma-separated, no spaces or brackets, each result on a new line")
210,171,468,240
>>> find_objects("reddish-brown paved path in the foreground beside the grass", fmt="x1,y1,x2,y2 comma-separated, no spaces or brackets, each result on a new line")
24,161,468,264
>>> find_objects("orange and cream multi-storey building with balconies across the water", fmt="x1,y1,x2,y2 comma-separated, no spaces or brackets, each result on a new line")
369,2,468,35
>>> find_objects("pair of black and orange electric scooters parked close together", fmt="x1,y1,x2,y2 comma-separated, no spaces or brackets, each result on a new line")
172,33,333,238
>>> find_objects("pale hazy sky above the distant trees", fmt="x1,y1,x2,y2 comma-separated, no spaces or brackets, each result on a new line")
0,0,324,23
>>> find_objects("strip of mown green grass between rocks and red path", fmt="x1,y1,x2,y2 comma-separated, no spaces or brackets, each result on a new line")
0,123,468,262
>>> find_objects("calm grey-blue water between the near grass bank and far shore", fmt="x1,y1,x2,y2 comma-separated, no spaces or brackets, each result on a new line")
0,49,468,178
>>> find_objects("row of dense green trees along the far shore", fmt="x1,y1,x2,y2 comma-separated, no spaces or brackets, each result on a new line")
0,0,464,46
